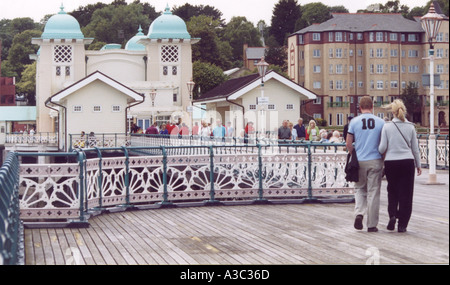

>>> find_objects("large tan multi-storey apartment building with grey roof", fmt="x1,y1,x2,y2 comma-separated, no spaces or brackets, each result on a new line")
288,8,449,126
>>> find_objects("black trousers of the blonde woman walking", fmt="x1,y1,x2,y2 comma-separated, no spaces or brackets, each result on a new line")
384,159,415,228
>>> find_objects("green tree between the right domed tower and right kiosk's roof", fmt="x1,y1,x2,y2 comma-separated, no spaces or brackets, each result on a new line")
193,61,228,99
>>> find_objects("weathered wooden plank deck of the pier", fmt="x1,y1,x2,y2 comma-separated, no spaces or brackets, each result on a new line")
25,170,449,265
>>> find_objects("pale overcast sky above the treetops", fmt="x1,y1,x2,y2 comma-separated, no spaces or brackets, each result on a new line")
0,0,427,25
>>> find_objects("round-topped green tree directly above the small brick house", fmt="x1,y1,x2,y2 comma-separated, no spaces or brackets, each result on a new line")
221,17,261,61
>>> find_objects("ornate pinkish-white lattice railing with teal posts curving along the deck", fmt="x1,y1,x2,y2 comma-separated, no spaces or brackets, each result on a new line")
17,144,354,225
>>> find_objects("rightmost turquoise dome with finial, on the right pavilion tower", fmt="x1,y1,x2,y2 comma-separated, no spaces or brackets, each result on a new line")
148,6,191,39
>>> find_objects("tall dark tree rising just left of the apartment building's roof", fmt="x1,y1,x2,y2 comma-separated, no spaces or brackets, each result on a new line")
270,0,301,46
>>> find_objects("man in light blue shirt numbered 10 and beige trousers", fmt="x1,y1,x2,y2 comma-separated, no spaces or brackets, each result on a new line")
346,96,384,232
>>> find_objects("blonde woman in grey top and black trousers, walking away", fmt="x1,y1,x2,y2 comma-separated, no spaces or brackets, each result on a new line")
378,99,422,232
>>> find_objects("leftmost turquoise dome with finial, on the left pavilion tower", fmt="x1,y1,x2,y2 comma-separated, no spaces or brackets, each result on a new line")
41,6,84,39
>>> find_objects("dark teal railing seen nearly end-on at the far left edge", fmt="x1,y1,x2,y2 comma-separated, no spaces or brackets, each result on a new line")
0,153,24,265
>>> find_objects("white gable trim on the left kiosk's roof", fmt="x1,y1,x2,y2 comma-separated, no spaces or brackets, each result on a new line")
51,72,144,102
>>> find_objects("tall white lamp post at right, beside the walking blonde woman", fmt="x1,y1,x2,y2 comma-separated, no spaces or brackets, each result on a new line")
420,2,443,184
